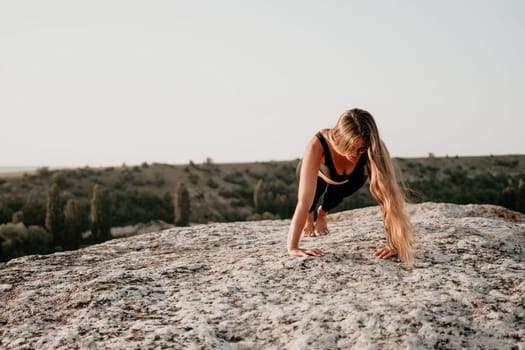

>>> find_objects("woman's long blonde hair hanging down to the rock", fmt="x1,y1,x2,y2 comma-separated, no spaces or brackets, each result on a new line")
328,108,414,266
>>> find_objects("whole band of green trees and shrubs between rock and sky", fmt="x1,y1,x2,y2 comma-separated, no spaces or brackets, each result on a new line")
0,156,525,261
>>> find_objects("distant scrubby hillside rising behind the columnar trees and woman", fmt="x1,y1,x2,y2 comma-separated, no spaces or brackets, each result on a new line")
0,155,525,225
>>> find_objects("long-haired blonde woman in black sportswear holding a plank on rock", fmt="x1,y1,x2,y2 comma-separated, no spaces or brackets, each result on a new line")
288,109,413,266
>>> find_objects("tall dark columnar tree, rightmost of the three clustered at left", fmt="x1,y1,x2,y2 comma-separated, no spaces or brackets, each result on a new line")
89,184,111,243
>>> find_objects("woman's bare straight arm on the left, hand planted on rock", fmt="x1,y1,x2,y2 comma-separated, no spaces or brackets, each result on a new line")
288,137,324,256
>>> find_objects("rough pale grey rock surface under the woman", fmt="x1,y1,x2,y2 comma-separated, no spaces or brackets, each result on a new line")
0,203,525,349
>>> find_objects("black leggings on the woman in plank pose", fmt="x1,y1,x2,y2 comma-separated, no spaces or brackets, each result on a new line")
309,177,366,213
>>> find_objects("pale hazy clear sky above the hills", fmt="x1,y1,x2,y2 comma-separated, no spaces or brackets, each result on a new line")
0,0,525,167
